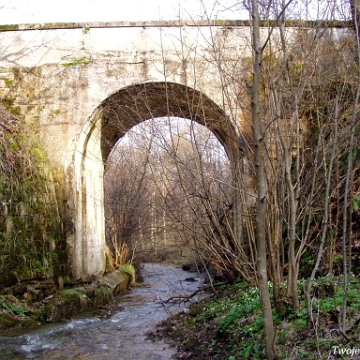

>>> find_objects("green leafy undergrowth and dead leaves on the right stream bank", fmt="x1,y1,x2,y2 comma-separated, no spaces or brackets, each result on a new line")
163,278,360,360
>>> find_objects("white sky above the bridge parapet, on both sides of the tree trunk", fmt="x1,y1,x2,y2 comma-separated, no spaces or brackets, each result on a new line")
0,0,349,25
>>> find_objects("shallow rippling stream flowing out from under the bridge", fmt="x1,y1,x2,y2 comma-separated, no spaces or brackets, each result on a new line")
0,264,200,360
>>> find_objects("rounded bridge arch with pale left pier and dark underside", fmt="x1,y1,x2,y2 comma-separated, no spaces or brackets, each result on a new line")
72,82,242,280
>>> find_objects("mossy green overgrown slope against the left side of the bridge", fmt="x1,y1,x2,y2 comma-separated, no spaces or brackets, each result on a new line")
0,105,67,289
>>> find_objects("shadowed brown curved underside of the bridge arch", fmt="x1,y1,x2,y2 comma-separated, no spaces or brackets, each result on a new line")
100,82,234,161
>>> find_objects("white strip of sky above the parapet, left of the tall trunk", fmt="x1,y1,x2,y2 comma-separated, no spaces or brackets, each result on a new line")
0,0,246,24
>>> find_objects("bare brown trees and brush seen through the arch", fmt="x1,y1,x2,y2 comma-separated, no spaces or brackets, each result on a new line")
106,119,239,275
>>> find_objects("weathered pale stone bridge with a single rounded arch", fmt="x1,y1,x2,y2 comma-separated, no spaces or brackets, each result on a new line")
0,21,344,279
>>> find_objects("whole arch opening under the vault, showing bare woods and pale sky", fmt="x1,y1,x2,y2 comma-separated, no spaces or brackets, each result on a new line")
104,117,232,266
